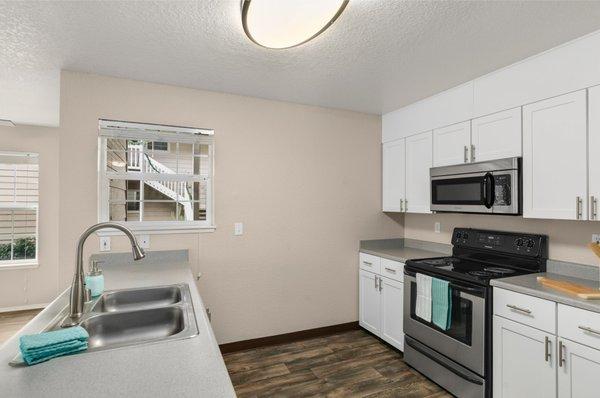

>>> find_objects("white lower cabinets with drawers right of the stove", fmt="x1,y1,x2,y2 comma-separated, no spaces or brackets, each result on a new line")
493,288,600,398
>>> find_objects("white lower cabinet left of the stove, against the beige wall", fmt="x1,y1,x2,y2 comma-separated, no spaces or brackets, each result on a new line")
358,255,404,351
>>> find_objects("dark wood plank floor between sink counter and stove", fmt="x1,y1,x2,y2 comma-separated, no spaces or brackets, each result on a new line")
224,330,451,398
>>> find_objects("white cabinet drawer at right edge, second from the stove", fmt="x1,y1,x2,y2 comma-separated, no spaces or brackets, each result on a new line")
558,304,600,349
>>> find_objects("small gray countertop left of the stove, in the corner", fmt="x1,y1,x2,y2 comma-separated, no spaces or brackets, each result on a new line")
359,239,452,263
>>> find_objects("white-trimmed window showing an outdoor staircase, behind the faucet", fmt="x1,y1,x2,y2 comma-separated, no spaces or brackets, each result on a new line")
99,120,214,230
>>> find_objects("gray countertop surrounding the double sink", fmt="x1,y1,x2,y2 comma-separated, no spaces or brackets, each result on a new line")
0,255,235,398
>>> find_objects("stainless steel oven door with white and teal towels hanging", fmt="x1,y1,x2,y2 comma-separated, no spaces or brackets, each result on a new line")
404,271,486,376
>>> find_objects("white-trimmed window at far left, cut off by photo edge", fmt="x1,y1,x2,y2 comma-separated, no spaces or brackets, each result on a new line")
0,152,39,267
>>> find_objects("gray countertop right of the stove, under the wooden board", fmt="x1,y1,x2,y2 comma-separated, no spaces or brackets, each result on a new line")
491,272,600,312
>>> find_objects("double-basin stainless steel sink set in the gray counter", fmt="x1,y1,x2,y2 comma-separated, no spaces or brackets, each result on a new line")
11,284,198,364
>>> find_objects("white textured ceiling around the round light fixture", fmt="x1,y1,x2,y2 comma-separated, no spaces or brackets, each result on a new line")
0,0,600,121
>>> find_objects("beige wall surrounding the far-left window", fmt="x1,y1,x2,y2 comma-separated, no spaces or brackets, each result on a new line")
0,126,59,309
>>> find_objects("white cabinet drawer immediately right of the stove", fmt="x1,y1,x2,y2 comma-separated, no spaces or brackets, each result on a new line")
494,287,556,334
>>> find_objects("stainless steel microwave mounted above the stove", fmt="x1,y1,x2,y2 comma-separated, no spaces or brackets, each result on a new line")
430,158,522,215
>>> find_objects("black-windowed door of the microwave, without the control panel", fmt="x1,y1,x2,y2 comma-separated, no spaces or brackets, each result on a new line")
431,173,494,213
